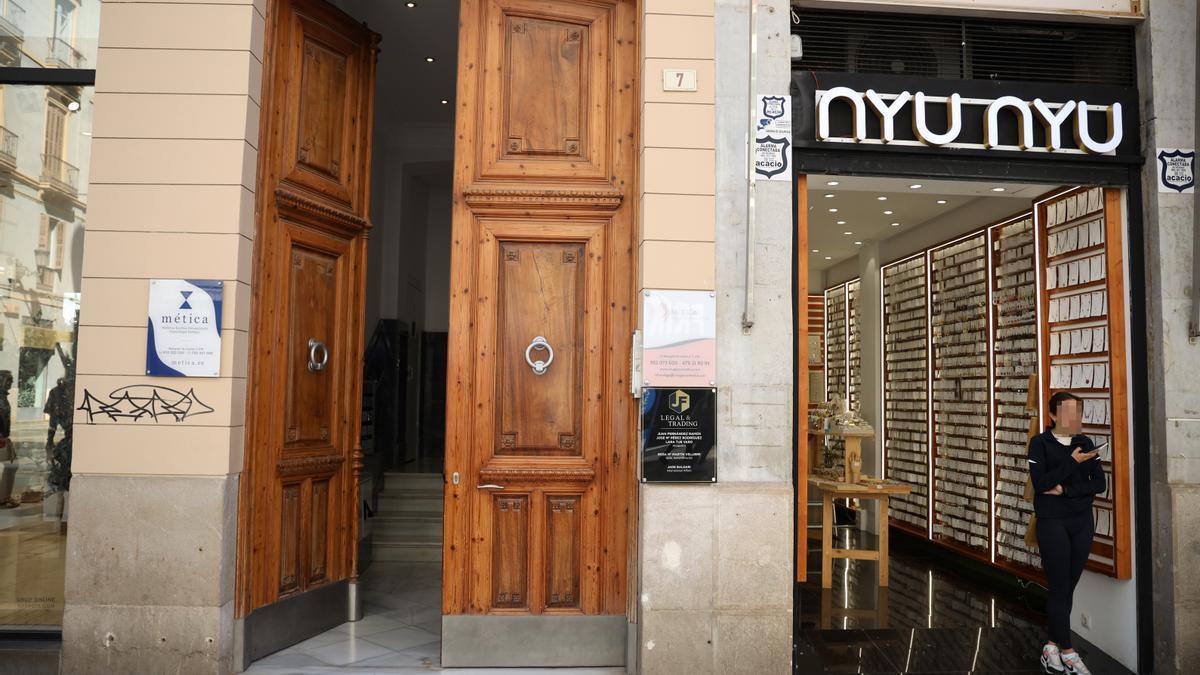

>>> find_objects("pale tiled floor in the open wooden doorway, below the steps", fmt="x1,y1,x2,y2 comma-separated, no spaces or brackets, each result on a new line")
246,562,625,675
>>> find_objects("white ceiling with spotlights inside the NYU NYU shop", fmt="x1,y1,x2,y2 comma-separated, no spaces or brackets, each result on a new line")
809,174,1052,270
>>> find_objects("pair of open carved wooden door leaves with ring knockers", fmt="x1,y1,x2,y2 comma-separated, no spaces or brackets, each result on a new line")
238,0,640,665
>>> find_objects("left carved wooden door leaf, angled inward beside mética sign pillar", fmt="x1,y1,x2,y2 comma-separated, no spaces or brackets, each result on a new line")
238,0,377,661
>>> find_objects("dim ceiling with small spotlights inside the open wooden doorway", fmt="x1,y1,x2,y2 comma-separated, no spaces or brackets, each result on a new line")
334,0,458,126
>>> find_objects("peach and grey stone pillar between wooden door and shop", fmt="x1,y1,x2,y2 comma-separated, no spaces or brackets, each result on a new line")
635,0,793,674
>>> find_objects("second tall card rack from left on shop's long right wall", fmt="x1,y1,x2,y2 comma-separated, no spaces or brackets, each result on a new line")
929,232,991,552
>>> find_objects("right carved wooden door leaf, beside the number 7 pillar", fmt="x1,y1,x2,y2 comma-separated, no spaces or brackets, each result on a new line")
443,0,638,665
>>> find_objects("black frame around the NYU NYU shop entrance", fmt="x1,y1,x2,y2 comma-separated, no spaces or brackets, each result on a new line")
791,70,1154,673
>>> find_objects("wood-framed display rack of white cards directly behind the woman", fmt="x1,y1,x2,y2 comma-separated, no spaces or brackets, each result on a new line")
1037,187,1133,579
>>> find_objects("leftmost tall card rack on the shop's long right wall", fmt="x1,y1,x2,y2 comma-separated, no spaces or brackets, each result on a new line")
880,255,929,536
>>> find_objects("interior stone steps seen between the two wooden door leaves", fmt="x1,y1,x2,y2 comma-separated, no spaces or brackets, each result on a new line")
372,472,442,562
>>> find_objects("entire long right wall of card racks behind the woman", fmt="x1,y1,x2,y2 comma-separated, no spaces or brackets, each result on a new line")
880,187,1132,579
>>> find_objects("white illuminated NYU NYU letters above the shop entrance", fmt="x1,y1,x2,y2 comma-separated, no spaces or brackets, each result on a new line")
815,86,1124,155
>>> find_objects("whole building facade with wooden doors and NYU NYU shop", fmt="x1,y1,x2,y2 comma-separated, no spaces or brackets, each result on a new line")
0,0,1200,673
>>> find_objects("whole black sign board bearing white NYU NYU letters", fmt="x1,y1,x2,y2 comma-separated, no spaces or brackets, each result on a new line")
792,71,1141,163
